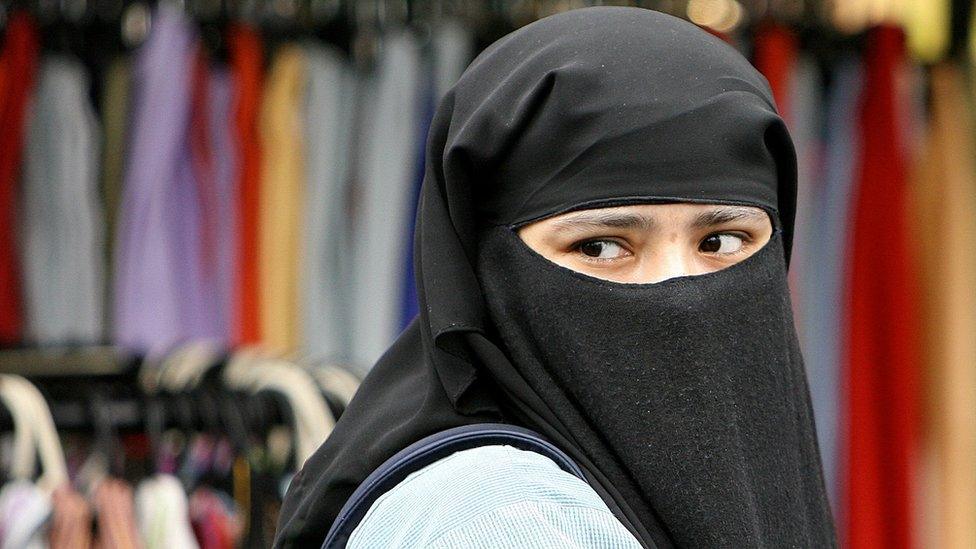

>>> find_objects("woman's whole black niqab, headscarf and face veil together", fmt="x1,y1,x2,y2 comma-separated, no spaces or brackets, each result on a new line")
276,7,835,547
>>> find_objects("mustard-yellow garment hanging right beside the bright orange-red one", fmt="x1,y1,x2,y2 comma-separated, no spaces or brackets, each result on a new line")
258,44,307,352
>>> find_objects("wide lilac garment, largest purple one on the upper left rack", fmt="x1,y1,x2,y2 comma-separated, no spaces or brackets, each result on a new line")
113,5,219,355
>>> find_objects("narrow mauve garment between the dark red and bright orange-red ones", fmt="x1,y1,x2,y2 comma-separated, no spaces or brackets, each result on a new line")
208,67,237,344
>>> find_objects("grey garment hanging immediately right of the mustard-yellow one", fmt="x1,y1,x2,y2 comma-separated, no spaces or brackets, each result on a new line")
301,44,356,360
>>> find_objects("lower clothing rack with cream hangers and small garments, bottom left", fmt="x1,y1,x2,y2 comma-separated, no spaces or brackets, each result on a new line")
0,341,358,549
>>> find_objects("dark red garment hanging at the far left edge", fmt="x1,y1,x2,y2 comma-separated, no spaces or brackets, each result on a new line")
0,11,40,344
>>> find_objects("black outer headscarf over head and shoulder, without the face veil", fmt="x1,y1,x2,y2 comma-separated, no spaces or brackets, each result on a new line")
276,7,832,547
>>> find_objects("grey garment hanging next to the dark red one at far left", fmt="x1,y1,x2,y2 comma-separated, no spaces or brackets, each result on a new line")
20,56,105,345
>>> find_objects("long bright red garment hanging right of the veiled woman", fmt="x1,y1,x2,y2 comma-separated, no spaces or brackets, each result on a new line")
842,27,921,549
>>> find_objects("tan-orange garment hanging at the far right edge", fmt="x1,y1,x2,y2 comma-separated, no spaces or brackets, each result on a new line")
910,64,976,547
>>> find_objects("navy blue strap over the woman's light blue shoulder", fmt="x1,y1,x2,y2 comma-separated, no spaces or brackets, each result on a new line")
322,423,586,549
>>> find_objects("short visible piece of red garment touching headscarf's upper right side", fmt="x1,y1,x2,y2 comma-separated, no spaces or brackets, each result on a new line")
753,21,799,124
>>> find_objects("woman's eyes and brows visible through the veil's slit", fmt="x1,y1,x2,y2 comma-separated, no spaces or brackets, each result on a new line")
519,204,773,283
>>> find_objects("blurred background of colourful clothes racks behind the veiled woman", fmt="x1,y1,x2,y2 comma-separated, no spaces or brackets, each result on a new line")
0,0,976,549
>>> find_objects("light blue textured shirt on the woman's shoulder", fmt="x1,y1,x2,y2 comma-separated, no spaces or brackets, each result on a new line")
347,446,640,549
